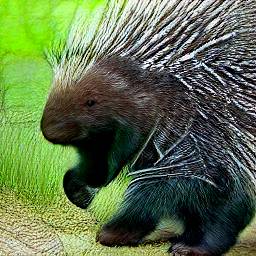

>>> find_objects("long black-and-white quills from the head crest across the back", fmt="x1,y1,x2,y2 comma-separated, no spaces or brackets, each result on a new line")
50,0,256,190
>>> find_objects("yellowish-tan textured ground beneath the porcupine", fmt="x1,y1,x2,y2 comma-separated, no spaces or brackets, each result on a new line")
0,190,256,256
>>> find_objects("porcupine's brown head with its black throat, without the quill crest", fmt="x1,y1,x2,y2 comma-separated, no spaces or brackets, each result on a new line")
41,45,192,205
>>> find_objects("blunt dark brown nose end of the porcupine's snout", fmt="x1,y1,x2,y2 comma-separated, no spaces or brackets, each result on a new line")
41,113,79,144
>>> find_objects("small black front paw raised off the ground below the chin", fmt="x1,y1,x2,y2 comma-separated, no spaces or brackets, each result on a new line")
63,170,97,209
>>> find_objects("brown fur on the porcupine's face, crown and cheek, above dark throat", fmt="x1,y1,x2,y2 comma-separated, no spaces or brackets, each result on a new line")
42,57,190,147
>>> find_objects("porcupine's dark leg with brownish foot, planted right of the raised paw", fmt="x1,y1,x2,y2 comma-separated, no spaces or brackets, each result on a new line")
97,184,162,246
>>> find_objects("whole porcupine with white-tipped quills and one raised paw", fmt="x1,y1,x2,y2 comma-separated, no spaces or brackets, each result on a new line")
41,0,256,255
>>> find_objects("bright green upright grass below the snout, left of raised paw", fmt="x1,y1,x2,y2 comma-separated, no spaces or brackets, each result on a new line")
0,121,74,204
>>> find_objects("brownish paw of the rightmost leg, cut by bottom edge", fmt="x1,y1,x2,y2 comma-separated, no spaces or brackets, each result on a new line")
169,243,213,256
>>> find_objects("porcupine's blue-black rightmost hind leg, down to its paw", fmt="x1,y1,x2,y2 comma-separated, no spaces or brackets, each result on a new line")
170,173,255,256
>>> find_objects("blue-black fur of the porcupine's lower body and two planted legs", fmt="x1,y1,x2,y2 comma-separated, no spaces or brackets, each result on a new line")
98,164,255,255
